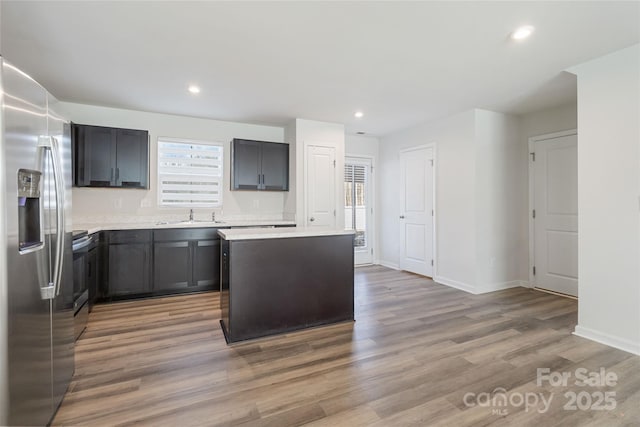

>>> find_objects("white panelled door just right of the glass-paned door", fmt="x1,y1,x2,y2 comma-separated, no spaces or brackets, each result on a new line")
400,147,434,277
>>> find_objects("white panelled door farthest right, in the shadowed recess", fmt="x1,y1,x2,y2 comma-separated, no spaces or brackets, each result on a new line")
532,134,578,296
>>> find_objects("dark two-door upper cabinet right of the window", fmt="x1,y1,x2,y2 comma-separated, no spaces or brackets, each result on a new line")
231,138,289,191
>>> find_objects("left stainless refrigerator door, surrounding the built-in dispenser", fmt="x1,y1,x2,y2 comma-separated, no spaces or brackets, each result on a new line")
2,58,52,425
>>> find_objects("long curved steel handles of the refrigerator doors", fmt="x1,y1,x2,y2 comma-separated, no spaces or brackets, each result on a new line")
39,136,65,299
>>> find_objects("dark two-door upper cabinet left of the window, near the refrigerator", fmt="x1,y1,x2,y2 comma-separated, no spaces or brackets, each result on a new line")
72,124,149,188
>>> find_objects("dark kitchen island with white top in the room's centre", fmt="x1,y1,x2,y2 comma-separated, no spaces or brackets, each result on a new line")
218,227,354,343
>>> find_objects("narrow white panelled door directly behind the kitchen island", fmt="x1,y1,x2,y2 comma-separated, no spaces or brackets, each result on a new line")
306,145,336,227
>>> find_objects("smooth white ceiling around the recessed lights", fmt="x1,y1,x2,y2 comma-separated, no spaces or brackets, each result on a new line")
0,0,640,135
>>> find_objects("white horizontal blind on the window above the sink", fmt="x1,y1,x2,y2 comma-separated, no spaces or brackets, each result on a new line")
158,138,224,208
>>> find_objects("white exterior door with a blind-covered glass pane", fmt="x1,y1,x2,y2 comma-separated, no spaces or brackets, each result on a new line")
344,157,373,265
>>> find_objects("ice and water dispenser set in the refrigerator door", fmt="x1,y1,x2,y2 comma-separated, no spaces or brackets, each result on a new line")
18,169,43,252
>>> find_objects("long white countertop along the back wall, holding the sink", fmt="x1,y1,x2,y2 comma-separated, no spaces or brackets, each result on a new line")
73,220,295,234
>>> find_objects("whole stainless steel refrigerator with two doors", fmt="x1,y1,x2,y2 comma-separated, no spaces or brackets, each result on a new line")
0,57,74,425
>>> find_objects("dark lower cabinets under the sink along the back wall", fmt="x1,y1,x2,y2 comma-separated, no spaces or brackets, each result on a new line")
102,225,292,302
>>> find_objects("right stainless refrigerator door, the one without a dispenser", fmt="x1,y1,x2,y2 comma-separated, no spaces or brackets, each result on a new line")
48,95,75,411
